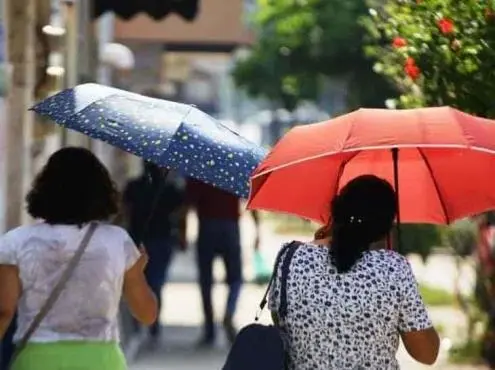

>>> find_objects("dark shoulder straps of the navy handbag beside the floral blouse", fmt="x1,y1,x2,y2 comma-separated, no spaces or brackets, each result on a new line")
255,241,302,321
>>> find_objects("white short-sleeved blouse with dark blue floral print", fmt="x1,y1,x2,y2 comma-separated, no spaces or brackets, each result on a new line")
269,244,432,370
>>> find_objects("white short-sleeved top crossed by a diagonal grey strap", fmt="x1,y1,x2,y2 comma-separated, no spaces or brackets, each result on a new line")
0,223,140,342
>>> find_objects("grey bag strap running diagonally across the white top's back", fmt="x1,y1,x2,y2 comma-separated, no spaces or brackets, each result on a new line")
8,222,98,369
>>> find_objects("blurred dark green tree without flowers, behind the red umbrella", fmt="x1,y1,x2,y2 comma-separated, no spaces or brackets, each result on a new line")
233,0,400,110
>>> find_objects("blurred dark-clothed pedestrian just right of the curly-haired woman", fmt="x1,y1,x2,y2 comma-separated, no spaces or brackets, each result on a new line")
123,162,185,341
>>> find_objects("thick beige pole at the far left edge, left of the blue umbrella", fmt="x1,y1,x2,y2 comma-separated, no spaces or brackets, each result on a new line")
5,0,36,229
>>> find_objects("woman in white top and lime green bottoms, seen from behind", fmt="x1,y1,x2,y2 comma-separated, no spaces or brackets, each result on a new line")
0,148,157,370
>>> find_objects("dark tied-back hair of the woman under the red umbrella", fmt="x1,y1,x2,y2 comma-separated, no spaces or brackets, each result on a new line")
330,175,397,273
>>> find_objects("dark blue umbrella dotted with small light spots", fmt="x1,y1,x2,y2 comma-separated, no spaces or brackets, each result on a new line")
31,84,267,198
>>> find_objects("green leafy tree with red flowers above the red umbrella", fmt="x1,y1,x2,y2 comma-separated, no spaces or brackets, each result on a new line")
362,0,495,117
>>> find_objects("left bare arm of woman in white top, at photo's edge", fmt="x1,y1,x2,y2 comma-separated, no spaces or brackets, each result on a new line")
0,265,22,338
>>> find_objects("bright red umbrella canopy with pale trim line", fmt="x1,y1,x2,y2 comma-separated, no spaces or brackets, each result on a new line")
248,107,495,224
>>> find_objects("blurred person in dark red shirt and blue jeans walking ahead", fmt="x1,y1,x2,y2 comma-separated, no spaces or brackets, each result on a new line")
183,179,259,346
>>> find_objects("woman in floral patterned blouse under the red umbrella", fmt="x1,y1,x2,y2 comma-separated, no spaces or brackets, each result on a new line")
270,175,439,370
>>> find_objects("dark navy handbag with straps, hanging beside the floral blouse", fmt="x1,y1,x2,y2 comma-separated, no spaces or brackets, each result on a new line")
222,241,301,370
